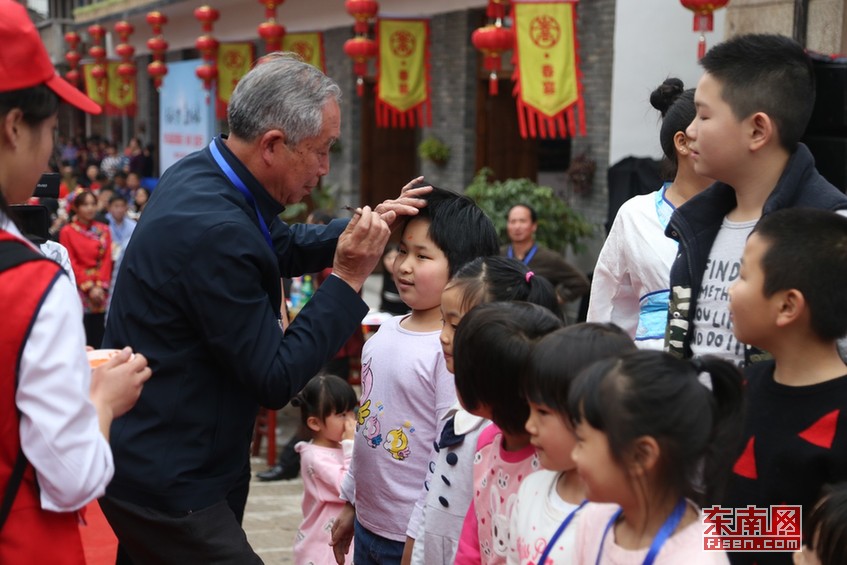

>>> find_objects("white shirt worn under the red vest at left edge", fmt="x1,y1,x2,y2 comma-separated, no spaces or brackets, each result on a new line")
0,213,114,512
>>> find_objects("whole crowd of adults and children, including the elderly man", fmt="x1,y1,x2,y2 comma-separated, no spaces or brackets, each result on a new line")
0,0,847,565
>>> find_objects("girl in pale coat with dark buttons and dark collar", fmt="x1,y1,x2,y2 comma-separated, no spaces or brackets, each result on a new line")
405,255,561,565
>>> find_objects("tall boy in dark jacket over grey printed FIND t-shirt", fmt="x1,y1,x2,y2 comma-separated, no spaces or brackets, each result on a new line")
665,35,847,365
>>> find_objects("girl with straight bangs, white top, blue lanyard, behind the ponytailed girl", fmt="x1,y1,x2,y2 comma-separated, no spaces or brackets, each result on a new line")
508,323,635,565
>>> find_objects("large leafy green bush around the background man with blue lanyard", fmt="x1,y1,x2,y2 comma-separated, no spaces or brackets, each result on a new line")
465,168,594,252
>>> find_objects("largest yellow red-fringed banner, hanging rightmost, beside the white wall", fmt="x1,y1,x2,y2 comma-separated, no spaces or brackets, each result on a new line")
512,0,585,139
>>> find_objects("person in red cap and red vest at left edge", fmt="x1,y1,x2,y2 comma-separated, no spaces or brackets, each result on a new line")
0,0,150,564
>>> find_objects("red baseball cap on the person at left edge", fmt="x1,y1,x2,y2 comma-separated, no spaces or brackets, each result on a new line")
0,0,102,114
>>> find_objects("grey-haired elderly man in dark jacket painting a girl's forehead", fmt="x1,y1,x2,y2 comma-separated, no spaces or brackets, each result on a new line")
101,54,430,563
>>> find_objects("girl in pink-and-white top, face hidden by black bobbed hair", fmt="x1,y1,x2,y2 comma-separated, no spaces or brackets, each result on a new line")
454,302,561,564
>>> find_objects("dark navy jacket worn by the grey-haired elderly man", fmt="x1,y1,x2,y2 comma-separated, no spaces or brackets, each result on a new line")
104,140,367,517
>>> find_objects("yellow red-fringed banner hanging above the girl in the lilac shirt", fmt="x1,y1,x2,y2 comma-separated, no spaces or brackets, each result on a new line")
376,19,432,128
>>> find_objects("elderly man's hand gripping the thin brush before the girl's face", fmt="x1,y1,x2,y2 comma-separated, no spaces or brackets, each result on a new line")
332,206,394,292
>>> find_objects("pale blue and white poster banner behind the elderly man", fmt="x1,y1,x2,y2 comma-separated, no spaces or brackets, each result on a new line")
159,59,215,173
